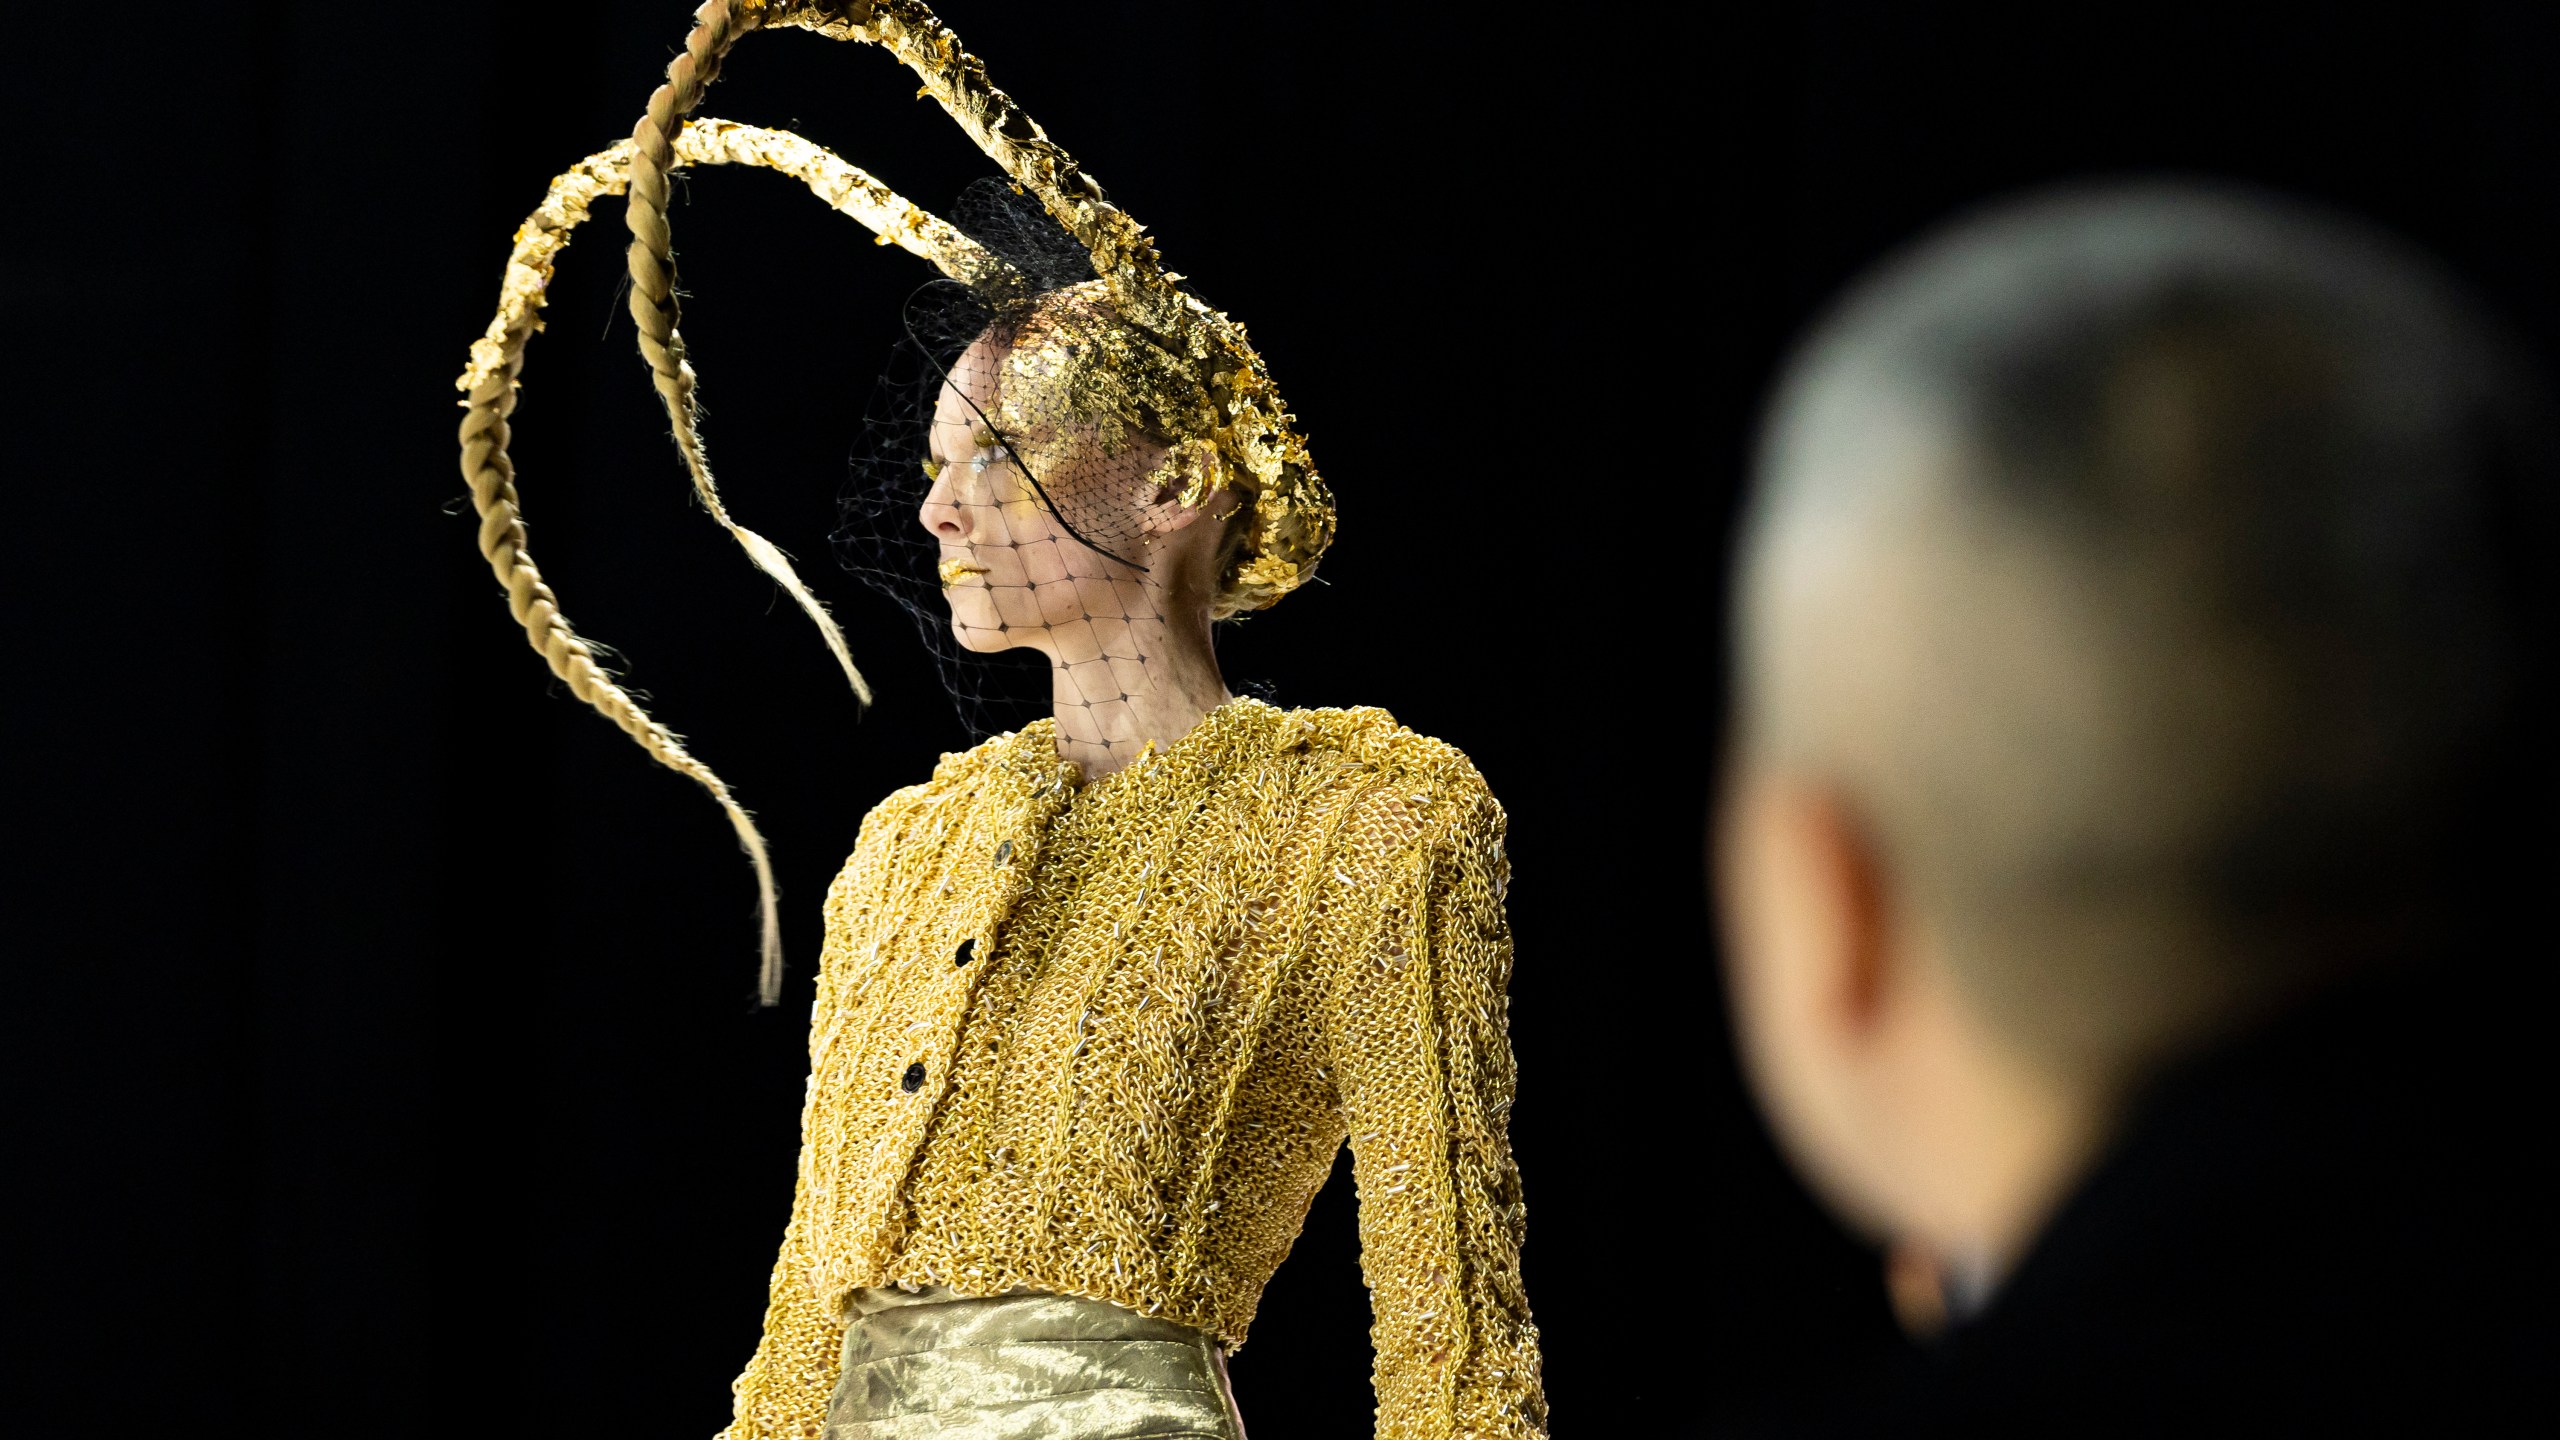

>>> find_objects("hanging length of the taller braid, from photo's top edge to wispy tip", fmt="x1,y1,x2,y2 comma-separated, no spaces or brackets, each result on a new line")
622,0,870,705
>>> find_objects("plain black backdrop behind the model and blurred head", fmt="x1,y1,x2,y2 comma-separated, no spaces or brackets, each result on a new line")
20,0,2560,1440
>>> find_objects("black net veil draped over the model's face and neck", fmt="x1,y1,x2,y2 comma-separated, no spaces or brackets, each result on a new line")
837,182,1242,756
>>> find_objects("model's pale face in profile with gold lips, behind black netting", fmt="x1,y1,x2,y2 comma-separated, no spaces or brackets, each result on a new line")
916,322,1234,661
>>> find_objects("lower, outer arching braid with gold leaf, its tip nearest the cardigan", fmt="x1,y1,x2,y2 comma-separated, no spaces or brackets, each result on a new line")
456,120,1001,1004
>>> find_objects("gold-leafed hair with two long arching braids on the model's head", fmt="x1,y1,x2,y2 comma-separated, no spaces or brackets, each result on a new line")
458,0,1334,1004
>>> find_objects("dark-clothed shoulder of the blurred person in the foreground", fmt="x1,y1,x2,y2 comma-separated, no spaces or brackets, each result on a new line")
1710,958,2560,1437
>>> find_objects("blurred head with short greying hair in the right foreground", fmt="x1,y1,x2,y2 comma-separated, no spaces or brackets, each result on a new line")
1718,184,2547,1301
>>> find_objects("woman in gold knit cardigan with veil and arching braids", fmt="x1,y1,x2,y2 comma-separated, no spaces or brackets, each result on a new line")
463,0,1546,1440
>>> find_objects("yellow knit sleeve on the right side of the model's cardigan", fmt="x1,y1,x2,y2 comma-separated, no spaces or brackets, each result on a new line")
1321,769,1546,1440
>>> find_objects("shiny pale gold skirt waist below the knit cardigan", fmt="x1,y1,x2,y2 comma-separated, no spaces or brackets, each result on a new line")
824,1286,1244,1440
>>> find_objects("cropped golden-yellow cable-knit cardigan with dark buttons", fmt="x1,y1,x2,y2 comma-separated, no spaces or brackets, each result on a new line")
724,700,1546,1440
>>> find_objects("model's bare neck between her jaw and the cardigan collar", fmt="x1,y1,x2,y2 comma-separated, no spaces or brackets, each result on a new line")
1050,612,1229,784
